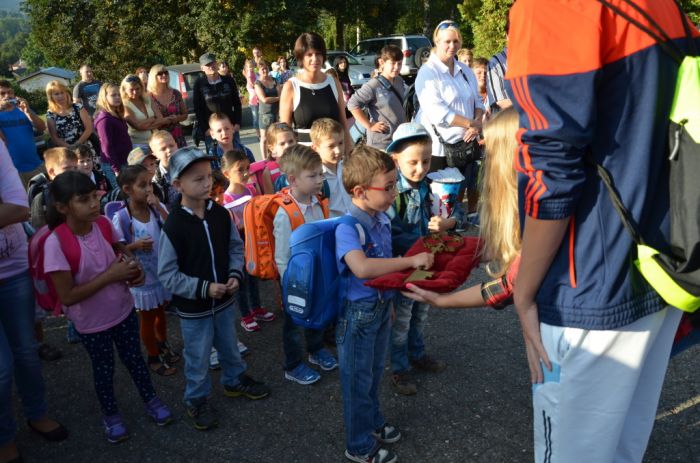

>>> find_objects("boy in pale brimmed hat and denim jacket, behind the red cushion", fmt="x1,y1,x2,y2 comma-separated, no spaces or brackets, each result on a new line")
386,122,461,395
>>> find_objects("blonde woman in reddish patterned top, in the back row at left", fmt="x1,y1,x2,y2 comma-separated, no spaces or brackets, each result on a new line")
147,64,187,148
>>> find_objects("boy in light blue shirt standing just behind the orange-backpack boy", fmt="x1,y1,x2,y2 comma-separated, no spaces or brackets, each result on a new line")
310,117,351,217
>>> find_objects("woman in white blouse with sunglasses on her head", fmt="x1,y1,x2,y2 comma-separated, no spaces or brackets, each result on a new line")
416,20,484,171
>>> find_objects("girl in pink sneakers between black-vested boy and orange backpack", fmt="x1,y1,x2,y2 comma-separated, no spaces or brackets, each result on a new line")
221,150,275,332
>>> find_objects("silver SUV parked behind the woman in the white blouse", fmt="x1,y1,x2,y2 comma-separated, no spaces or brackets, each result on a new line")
350,34,432,80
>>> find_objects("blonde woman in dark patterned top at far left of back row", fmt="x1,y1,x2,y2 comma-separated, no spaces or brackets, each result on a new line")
46,80,93,149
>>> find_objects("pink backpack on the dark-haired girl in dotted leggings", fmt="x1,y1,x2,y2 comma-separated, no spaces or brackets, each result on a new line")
29,216,112,315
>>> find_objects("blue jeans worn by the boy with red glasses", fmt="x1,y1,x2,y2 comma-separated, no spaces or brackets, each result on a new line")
336,299,391,455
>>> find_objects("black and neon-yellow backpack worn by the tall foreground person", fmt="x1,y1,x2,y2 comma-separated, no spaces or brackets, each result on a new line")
596,0,700,312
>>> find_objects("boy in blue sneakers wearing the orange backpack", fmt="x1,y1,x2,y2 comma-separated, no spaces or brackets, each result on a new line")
273,145,338,385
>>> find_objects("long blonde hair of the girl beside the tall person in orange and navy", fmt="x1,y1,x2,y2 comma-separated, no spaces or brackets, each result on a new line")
479,108,521,278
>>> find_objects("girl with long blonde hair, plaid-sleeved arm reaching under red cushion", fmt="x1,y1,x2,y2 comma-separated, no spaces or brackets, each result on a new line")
404,108,521,308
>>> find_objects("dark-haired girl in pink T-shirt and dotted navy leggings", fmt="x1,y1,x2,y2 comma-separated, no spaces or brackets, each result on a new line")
44,172,173,443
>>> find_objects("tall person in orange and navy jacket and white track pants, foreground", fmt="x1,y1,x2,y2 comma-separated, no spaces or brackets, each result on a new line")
508,0,698,463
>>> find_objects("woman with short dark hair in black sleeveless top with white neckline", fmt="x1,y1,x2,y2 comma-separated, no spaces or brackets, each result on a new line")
280,32,352,153
